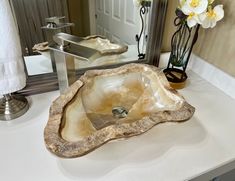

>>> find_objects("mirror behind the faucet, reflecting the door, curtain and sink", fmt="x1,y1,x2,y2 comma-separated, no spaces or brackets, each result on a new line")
11,0,166,94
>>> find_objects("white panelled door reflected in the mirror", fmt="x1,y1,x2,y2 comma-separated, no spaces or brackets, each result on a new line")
95,0,141,45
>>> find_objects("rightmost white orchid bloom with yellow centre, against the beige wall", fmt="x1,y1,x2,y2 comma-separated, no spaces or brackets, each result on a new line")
199,5,224,28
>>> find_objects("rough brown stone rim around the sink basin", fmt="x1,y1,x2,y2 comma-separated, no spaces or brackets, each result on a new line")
44,64,195,158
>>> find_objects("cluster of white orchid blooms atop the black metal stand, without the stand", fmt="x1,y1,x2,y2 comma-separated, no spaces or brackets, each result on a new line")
176,0,224,28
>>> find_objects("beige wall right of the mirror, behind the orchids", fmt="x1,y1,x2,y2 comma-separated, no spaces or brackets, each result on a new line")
162,0,235,77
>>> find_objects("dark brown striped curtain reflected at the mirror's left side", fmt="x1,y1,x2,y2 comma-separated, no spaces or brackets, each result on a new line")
12,0,68,55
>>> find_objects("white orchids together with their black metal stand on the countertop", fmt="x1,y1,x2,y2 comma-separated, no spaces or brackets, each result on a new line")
163,0,224,89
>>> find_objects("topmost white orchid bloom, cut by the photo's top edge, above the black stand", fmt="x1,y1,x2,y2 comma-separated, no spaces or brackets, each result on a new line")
181,0,208,15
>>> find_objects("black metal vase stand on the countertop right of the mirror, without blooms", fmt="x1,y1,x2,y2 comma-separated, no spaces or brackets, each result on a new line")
164,12,200,88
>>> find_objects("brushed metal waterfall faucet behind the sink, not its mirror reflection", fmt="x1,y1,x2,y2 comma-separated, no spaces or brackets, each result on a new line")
49,33,102,94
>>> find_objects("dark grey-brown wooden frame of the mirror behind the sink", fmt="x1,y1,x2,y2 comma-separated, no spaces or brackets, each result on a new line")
17,0,167,96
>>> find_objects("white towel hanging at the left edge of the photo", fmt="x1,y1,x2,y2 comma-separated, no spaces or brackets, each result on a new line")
0,0,26,95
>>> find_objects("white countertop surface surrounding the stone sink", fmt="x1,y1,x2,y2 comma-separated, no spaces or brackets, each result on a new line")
0,71,235,181
